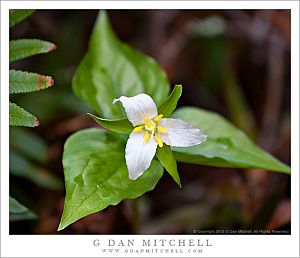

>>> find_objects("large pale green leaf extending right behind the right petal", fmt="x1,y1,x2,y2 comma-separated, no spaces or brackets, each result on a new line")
172,107,290,174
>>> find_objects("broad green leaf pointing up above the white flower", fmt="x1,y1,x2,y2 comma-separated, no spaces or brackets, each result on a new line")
72,11,170,119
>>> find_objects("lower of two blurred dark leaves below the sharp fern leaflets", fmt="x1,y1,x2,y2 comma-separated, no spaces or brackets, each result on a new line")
9,150,63,190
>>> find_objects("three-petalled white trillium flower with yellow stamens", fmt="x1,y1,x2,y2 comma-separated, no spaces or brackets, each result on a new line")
113,94,207,180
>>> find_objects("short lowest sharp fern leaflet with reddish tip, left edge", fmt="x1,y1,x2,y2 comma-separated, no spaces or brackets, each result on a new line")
9,102,40,127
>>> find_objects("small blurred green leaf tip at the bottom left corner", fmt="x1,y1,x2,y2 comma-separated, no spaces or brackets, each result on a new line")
9,196,37,221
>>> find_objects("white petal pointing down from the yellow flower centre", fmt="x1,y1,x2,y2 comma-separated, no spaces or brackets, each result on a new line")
125,132,157,180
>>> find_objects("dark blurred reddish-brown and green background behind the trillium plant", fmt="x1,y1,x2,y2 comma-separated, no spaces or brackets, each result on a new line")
10,10,291,234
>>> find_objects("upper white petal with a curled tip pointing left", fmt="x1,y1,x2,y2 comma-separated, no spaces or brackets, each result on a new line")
113,94,157,126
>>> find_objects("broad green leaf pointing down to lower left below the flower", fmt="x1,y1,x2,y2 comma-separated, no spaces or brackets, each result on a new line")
58,128,163,230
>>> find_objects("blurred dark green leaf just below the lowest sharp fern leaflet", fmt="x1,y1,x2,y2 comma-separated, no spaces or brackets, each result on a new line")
9,127,48,164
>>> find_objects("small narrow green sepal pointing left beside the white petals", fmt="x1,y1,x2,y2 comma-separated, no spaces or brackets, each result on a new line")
87,113,134,134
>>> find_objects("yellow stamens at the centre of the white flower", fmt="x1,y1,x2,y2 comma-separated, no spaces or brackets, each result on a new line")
133,115,167,147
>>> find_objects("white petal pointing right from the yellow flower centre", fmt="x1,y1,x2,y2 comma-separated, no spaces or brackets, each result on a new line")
159,118,207,147
